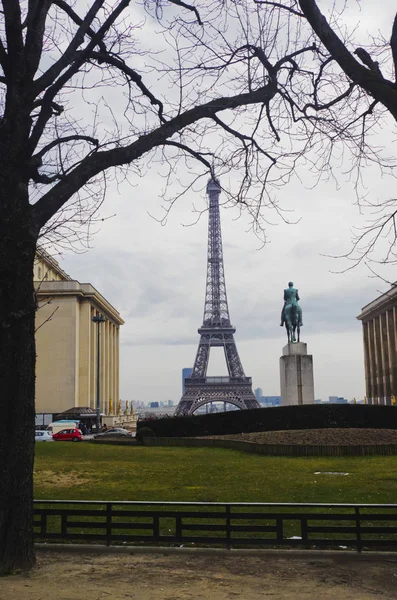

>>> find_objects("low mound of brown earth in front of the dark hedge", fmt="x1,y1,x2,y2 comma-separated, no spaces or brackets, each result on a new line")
201,429,397,446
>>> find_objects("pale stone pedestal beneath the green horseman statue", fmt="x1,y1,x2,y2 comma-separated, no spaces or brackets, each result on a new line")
280,342,314,406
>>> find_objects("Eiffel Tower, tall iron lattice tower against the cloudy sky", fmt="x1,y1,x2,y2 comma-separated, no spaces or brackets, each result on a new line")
175,177,260,416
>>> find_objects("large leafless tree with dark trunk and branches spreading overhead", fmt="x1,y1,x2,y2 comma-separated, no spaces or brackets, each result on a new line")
0,0,397,572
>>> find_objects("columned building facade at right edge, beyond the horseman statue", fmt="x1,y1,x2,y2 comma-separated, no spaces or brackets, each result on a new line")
357,283,397,404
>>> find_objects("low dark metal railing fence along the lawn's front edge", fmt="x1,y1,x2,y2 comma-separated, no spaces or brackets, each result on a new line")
33,500,397,552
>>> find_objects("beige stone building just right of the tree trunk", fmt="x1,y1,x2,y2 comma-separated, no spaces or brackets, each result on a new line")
34,249,124,415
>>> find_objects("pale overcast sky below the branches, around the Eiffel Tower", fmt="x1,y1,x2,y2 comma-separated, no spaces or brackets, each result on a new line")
57,2,397,402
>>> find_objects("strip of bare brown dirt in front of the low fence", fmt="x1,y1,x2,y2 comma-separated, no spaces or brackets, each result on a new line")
0,552,397,600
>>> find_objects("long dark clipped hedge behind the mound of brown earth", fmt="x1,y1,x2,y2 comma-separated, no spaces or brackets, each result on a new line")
137,404,397,437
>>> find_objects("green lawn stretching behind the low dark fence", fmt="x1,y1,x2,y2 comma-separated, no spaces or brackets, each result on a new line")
35,442,397,503
